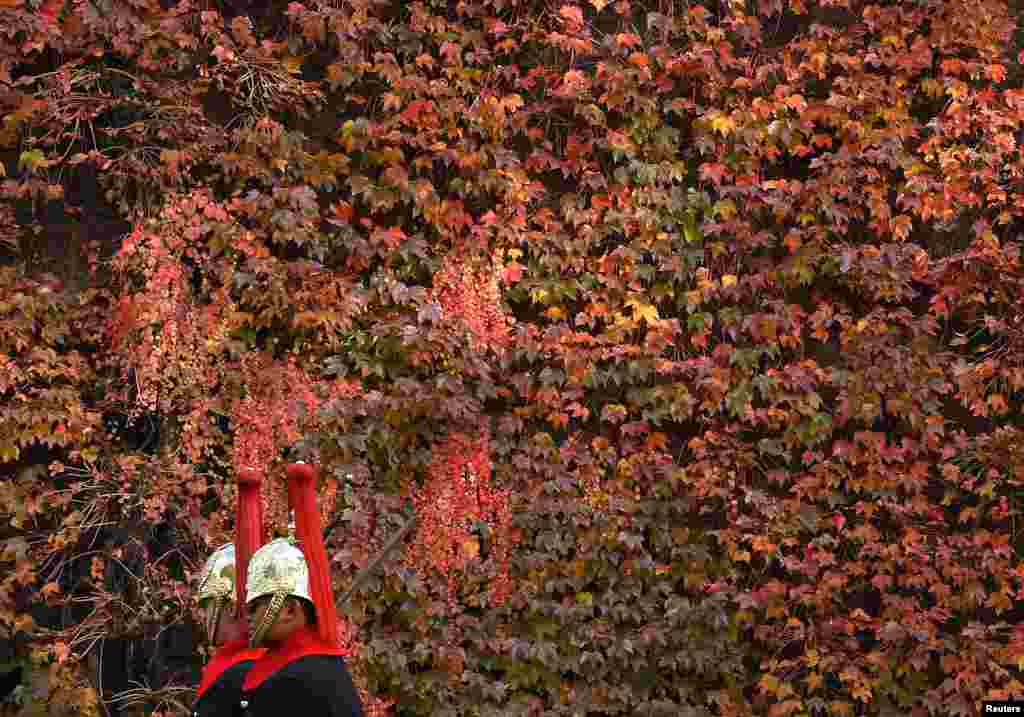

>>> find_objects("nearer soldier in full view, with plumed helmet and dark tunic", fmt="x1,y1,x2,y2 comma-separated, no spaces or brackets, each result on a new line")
239,464,362,717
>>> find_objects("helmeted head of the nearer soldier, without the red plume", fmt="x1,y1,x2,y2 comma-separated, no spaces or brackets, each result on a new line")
246,538,316,645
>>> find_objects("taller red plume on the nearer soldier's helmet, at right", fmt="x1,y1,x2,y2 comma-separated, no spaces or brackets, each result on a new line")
286,463,339,646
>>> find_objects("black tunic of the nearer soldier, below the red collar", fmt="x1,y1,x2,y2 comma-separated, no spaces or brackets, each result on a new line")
239,655,362,717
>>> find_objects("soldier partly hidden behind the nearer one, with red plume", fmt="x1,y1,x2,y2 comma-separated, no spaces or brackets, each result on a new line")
193,471,266,717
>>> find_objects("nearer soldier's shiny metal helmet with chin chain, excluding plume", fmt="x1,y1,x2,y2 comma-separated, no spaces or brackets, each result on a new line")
246,538,312,645
